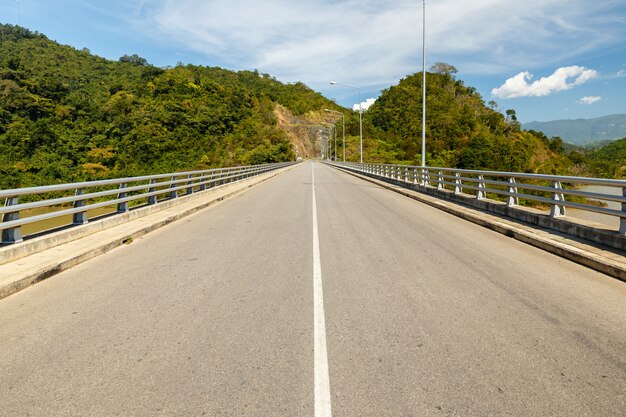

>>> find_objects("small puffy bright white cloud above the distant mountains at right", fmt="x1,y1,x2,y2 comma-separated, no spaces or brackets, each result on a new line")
491,65,598,99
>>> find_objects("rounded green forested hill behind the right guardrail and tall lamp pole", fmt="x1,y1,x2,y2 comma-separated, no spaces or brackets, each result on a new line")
366,64,572,173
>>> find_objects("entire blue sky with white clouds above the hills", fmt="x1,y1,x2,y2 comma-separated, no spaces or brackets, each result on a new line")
0,0,626,122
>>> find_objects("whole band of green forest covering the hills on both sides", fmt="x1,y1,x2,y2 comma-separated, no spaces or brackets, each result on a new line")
0,25,626,188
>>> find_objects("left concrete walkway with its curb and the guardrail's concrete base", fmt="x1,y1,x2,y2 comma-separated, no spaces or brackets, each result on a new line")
0,165,295,299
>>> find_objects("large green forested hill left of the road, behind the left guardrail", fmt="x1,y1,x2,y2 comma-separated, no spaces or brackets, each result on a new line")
0,25,338,188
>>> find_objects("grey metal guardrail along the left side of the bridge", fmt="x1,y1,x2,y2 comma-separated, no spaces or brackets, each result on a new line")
0,162,293,244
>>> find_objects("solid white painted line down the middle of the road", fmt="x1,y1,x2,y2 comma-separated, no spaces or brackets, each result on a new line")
311,164,332,417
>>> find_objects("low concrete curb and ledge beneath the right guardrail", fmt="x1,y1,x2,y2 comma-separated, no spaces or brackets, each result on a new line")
334,167,626,282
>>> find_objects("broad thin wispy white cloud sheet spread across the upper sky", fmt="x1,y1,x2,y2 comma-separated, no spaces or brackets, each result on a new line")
124,0,626,99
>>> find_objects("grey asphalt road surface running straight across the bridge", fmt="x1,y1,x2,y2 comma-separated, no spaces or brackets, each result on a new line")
0,162,626,417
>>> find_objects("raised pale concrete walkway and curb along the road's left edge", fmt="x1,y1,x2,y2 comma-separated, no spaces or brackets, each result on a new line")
0,165,296,299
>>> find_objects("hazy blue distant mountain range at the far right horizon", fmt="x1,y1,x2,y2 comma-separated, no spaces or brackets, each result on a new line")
522,114,626,145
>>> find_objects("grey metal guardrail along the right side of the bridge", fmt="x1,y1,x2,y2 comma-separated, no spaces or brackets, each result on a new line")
327,161,626,235
